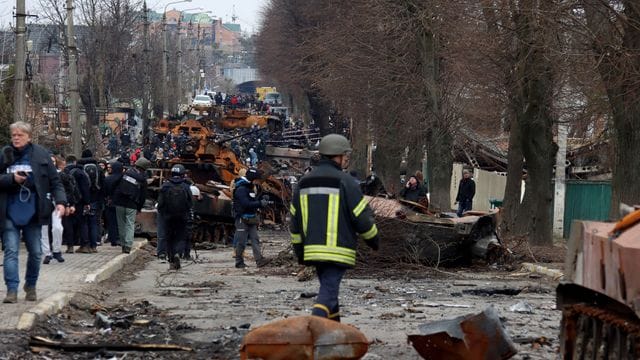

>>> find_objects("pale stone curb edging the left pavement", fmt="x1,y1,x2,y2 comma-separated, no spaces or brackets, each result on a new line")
16,240,148,330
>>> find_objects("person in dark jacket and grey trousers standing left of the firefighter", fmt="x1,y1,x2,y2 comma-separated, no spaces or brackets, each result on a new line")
233,168,268,269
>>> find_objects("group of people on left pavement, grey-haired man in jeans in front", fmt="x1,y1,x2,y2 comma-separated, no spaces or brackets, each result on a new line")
0,121,151,303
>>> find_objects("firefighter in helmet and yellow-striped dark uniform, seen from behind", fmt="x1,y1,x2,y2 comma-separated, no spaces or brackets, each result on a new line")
289,134,379,321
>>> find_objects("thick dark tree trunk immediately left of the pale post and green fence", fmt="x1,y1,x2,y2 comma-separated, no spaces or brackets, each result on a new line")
512,1,557,245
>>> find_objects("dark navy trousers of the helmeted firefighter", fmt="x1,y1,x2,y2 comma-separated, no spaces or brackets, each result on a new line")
311,263,347,322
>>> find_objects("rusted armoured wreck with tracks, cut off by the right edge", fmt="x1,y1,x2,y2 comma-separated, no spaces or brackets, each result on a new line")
557,207,640,359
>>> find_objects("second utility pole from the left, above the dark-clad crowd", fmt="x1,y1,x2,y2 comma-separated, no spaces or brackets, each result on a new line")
67,0,82,157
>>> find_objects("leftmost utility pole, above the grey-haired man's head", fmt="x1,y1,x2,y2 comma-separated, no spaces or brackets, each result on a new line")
13,0,27,121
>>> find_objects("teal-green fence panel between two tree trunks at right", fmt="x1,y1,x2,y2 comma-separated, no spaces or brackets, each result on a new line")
563,180,611,238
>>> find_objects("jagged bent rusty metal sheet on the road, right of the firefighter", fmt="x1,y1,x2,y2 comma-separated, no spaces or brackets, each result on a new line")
409,307,517,360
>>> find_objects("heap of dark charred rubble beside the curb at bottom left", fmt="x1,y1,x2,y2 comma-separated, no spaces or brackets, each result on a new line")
29,298,240,359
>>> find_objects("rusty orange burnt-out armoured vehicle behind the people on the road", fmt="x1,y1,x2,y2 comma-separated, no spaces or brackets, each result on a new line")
136,119,291,242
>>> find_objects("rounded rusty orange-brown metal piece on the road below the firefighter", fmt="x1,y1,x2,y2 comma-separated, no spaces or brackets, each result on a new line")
240,316,369,360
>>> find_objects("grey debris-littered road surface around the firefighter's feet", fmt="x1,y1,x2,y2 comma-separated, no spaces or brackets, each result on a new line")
0,231,560,359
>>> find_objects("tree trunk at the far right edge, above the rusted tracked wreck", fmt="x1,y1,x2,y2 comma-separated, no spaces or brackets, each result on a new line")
583,0,640,219
